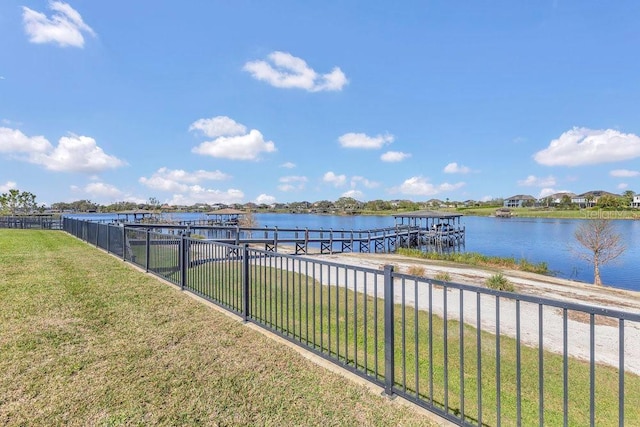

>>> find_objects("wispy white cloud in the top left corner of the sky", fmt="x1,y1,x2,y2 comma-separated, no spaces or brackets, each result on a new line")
22,1,95,47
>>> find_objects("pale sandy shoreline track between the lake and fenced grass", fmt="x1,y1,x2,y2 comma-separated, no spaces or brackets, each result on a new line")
296,253,640,375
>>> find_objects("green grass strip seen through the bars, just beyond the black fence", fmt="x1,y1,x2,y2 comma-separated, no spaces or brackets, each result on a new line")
182,258,640,426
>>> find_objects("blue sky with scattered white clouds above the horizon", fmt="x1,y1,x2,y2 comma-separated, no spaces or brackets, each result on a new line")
0,0,640,205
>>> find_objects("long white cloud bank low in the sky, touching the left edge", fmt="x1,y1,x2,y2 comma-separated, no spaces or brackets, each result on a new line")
0,127,126,173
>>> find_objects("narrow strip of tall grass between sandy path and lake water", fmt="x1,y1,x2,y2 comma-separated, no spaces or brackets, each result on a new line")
397,248,549,274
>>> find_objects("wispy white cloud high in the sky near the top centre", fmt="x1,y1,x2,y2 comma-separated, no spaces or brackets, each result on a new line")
243,51,348,92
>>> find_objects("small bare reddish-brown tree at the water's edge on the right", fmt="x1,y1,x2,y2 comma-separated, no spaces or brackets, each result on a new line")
574,218,626,286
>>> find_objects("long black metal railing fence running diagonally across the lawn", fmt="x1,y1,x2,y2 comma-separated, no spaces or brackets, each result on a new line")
63,219,640,426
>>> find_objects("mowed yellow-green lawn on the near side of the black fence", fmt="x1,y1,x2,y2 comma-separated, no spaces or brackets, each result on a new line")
0,230,436,426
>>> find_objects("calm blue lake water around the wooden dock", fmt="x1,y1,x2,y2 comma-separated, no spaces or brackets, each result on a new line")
70,213,640,291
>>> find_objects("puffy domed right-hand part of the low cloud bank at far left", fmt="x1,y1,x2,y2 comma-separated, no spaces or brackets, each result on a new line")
30,134,126,173
